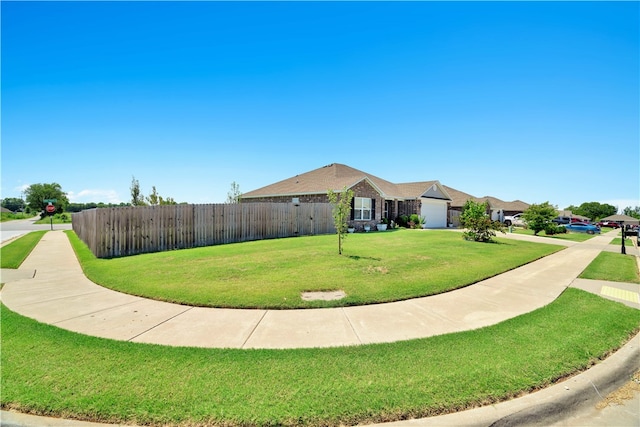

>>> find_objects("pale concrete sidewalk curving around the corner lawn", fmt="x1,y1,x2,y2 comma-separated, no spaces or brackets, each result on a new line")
0,231,636,348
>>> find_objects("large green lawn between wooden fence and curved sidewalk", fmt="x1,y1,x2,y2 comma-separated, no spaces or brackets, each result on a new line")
68,230,562,309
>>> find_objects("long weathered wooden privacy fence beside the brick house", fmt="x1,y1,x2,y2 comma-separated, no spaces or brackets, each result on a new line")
73,203,336,258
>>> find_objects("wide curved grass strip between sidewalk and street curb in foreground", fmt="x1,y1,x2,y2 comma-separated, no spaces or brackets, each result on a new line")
1,288,640,426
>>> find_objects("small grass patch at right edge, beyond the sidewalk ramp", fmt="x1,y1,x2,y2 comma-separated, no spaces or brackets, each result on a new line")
579,252,640,283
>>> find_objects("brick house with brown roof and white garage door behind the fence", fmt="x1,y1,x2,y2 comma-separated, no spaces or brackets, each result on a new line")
240,163,451,229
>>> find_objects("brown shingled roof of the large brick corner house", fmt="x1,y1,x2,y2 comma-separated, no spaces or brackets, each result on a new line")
242,163,448,200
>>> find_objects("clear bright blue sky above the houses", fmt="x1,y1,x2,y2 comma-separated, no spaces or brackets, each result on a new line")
0,1,640,209
